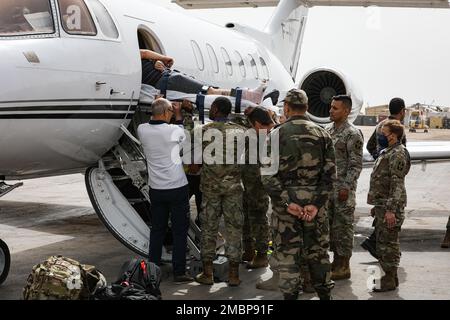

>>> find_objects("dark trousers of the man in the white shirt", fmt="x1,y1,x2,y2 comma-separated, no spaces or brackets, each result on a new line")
150,185,190,275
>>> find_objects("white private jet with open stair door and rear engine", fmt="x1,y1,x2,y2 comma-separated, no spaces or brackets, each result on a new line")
0,0,450,272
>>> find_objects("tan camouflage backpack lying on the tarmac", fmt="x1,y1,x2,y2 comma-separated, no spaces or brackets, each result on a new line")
23,256,106,300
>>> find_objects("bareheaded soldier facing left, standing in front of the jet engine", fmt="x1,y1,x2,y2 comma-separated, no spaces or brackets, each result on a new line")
326,95,364,280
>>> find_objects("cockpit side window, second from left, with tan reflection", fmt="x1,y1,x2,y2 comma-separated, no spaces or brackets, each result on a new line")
59,0,97,36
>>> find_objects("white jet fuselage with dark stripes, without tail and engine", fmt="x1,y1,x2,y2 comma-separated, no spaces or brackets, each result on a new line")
0,0,294,179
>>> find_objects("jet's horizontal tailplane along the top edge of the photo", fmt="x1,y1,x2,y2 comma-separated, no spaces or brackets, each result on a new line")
172,0,450,9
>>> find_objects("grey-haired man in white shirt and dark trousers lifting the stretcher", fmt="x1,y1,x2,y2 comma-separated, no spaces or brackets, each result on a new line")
137,99,193,283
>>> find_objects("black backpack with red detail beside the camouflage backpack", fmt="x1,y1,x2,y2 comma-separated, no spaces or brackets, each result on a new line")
93,258,161,300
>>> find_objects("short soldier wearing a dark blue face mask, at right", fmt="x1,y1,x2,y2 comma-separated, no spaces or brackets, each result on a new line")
367,120,411,291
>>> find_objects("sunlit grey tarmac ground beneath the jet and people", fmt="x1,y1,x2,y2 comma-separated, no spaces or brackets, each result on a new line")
0,126,450,300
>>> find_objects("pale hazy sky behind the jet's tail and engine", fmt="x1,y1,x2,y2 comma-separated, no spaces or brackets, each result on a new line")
152,0,450,106
